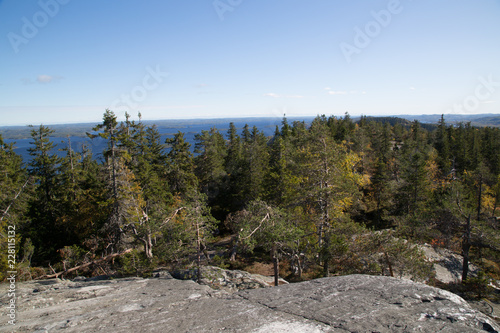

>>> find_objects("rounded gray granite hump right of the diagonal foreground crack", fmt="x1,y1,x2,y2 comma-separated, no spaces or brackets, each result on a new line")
239,275,499,332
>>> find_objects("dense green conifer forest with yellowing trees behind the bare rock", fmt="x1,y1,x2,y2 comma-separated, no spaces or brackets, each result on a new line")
0,110,500,294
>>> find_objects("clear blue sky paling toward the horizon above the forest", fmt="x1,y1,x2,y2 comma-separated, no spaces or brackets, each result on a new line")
0,0,500,126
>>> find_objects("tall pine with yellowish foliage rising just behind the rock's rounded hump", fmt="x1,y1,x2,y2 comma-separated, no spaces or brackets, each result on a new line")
298,117,363,276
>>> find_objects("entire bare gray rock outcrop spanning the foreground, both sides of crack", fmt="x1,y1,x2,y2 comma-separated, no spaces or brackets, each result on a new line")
0,274,500,333
